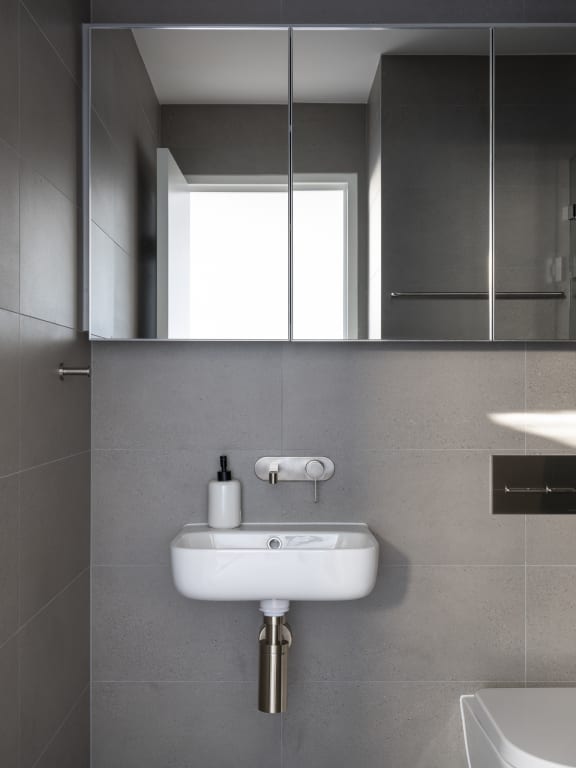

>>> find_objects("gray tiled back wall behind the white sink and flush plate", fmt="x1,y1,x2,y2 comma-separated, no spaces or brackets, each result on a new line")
90,0,576,768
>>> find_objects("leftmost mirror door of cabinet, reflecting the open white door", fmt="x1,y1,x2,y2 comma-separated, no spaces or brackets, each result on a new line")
89,28,289,339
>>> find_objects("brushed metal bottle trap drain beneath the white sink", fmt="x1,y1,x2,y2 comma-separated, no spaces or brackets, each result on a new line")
258,600,292,715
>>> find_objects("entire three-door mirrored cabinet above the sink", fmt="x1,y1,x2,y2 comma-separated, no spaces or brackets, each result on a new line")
84,25,576,341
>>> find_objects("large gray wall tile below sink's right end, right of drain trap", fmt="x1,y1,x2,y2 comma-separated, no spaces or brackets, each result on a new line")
289,566,524,681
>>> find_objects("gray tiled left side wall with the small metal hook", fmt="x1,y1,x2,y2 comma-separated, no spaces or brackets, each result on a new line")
0,0,90,768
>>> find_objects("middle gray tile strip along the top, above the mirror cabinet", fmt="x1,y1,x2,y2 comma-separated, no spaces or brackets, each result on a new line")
284,0,524,24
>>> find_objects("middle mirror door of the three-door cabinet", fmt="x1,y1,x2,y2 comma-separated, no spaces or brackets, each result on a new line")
293,29,490,340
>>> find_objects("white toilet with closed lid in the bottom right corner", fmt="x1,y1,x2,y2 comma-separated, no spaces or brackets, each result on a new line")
460,688,576,768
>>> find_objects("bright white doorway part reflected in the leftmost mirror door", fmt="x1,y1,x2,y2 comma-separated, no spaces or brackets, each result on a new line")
189,182,288,339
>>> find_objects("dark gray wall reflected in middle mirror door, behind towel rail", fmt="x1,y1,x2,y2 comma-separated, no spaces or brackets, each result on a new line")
381,51,490,339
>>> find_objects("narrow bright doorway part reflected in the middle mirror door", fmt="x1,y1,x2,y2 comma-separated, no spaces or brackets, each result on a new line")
293,174,358,339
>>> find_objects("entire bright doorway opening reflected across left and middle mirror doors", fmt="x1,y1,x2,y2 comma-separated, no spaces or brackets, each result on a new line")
159,174,358,339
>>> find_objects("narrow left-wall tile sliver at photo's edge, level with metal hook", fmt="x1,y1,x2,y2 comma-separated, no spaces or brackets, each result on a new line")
0,309,20,477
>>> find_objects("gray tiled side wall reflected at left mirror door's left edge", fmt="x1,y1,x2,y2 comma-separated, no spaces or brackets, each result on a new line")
90,30,160,338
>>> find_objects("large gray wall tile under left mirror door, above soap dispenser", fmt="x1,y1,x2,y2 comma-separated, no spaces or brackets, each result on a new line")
93,343,281,453
